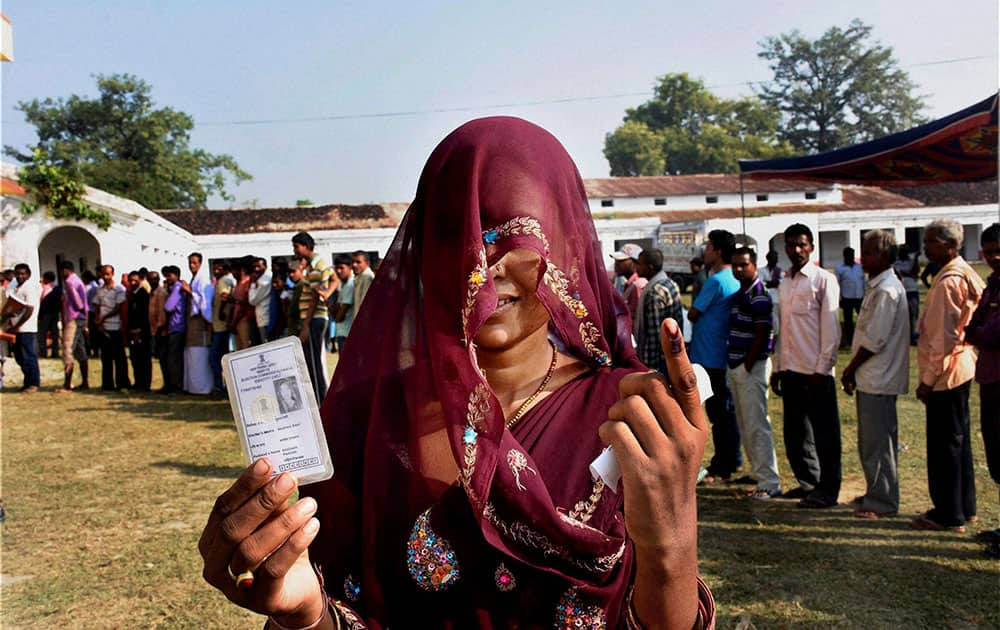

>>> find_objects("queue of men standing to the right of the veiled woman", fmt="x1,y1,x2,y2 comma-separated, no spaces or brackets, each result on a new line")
613,220,1000,554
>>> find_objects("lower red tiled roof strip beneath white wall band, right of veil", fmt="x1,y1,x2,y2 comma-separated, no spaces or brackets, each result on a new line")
594,186,924,223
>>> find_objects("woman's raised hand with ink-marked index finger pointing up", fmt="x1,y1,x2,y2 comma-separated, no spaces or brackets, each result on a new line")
600,319,708,564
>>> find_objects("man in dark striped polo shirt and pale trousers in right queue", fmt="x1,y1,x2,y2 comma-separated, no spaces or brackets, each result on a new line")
726,247,781,500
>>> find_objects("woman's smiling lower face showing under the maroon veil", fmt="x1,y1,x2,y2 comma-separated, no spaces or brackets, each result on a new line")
476,249,549,350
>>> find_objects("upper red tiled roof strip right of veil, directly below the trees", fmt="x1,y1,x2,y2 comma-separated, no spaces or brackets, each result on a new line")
583,174,833,198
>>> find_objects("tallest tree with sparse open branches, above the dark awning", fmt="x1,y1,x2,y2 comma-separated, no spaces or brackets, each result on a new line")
758,20,924,152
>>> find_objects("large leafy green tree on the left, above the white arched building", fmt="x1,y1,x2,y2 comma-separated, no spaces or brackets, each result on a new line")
4,74,251,208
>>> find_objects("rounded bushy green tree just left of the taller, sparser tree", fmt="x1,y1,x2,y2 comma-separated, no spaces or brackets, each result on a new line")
604,74,791,176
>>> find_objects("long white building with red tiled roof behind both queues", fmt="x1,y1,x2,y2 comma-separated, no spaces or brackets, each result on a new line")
0,164,998,282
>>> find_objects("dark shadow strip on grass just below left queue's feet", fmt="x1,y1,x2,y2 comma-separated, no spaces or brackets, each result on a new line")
66,389,235,429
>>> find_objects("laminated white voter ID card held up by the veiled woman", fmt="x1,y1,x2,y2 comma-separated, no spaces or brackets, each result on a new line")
222,337,333,485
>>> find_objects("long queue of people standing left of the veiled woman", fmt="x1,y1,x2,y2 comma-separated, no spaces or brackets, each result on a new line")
0,232,374,410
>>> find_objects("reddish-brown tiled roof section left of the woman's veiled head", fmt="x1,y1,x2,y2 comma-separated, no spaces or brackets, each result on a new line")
156,205,399,234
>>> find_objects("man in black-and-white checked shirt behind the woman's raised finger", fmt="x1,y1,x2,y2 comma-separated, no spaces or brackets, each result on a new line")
632,249,681,374
